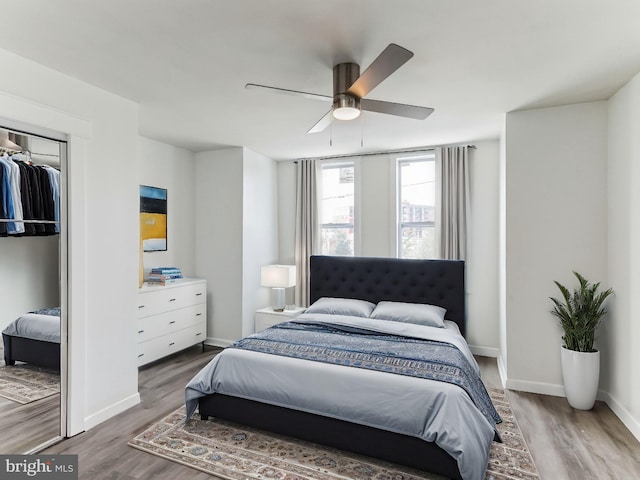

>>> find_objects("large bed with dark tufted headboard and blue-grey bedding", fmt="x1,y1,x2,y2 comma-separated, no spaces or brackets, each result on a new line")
185,256,500,480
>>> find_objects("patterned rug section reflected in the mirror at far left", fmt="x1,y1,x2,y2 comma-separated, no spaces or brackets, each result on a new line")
0,365,60,404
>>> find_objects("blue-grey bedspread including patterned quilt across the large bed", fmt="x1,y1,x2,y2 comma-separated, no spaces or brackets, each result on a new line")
185,313,499,480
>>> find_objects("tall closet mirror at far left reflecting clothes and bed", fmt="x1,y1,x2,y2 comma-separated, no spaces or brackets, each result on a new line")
0,128,64,454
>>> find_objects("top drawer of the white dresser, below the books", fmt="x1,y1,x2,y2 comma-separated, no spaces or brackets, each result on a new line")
138,282,207,318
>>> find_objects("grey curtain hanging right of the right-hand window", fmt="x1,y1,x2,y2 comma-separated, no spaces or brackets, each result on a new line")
436,146,471,260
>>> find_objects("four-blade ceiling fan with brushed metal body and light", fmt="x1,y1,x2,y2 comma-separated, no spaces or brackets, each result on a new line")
245,43,433,133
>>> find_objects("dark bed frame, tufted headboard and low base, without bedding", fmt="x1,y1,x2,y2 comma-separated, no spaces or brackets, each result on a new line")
199,256,465,480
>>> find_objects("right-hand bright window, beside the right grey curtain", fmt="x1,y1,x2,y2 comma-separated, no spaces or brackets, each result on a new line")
396,153,436,258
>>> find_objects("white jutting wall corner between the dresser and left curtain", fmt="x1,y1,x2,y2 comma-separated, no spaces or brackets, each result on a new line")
195,148,278,346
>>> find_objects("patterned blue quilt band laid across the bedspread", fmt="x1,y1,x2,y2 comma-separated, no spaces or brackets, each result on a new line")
228,321,502,425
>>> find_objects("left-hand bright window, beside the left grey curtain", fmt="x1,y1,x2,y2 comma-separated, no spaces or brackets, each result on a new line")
320,162,356,255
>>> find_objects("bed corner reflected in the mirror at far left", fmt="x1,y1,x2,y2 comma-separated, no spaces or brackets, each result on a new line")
2,307,60,371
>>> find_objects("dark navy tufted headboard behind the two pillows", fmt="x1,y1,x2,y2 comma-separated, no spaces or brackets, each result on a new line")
309,255,466,335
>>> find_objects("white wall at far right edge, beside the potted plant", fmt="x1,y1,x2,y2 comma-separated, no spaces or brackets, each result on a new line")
599,70,640,438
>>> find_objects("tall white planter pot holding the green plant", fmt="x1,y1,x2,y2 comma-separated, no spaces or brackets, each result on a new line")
560,347,600,410
